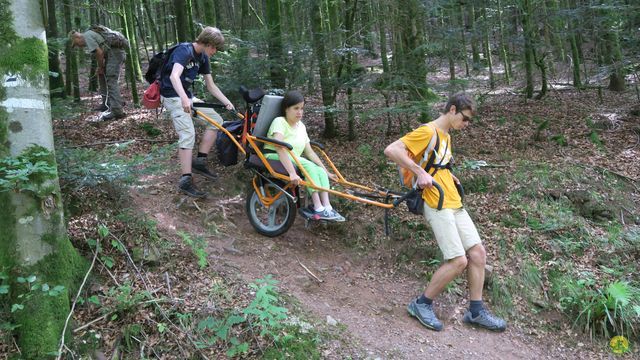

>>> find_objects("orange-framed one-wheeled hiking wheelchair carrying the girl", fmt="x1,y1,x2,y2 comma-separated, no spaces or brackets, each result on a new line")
188,87,444,237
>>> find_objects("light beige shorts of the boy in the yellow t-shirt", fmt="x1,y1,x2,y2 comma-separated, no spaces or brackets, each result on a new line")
424,206,481,260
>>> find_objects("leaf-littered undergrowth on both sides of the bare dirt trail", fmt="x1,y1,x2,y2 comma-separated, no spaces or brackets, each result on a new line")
3,84,640,358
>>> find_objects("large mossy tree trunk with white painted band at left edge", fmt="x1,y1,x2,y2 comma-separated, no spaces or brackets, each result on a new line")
0,0,85,359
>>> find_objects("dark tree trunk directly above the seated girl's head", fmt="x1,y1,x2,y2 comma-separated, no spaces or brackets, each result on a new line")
266,0,285,89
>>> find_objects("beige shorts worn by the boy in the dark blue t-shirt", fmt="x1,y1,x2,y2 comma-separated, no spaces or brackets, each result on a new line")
161,96,222,149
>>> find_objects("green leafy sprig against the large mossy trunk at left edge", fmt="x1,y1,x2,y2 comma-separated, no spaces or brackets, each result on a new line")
0,145,58,198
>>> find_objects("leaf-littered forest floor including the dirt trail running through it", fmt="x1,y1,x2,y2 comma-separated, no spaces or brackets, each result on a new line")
26,72,640,359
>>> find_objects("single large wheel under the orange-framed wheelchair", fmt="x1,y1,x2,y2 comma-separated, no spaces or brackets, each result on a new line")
245,182,296,237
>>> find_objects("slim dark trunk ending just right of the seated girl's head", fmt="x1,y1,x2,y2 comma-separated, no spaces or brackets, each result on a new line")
310,1,336,138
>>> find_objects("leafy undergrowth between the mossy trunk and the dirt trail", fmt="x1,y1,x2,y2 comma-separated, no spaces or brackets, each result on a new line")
45,145,356,359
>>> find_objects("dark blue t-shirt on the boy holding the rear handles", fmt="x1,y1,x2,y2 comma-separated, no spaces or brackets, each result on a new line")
160,43,211,98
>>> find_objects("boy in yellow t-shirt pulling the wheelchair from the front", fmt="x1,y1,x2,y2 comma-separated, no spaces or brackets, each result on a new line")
384,93,507,331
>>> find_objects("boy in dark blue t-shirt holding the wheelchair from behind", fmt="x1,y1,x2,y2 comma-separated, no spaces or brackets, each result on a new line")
160,26,234,197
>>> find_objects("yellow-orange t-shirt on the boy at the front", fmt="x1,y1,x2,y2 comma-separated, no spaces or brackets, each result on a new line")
400,123,462,209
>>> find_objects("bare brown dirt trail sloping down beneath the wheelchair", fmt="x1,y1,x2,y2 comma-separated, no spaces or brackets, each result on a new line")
133,171,607,359
